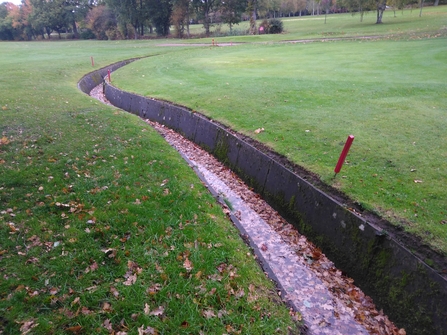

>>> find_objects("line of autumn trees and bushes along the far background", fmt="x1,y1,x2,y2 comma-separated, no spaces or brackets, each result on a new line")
0,0,439,40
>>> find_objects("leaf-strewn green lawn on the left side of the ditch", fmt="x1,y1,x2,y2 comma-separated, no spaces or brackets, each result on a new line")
0,41,298,334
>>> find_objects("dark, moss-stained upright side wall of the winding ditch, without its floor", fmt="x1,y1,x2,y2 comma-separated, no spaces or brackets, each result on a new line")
79,60,447,335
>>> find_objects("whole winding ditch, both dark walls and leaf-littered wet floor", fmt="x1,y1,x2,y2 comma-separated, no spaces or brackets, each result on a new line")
78,59,447,335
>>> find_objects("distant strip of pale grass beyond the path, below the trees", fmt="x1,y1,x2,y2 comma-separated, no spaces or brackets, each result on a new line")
173,6,447,43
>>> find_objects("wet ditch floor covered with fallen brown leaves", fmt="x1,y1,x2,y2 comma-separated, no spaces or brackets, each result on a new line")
90,85,406,335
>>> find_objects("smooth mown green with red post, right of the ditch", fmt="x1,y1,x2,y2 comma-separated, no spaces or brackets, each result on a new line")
111,7,447,253
